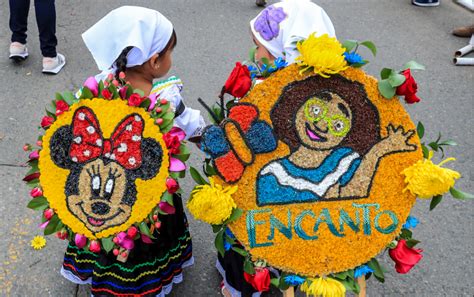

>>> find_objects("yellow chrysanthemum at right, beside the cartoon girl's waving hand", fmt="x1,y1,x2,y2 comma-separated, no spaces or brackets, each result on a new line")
402,151,461,199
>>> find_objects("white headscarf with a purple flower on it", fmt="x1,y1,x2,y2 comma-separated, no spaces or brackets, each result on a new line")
250,0,336,64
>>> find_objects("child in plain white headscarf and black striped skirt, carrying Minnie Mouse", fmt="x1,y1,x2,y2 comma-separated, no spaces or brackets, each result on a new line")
61,6,198,297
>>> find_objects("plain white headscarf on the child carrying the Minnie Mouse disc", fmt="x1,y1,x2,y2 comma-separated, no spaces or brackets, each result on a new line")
82,6,173,70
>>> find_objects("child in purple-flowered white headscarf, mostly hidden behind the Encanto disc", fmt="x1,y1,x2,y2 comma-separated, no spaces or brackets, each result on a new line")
216,0,335,297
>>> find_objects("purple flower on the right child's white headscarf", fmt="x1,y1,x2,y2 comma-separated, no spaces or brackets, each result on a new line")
253,6,286,41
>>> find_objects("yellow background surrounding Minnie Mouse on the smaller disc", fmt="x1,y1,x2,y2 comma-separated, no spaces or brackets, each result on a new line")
39,98,169,239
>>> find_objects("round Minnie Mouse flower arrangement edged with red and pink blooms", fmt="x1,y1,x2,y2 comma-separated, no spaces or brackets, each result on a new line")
24,75,189,261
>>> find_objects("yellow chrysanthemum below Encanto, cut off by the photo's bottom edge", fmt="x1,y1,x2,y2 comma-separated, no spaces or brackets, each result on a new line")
301,277,346,297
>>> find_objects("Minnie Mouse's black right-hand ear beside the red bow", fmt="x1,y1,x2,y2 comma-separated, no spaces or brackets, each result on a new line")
128,138,163,180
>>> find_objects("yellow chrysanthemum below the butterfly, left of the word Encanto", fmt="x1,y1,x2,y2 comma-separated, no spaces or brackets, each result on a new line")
187,177,237,225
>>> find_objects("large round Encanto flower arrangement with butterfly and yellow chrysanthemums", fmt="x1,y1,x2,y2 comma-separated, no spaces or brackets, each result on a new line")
188,34,472,296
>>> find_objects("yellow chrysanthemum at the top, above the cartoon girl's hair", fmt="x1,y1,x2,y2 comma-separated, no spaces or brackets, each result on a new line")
296,33,349,78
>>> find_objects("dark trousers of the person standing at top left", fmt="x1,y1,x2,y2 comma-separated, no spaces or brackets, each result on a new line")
10,0,58,58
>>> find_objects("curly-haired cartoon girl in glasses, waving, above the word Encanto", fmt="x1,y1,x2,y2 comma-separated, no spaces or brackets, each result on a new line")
257,75,416,206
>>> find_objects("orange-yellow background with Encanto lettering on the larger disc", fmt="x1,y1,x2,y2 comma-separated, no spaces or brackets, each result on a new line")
225,65,422,277
